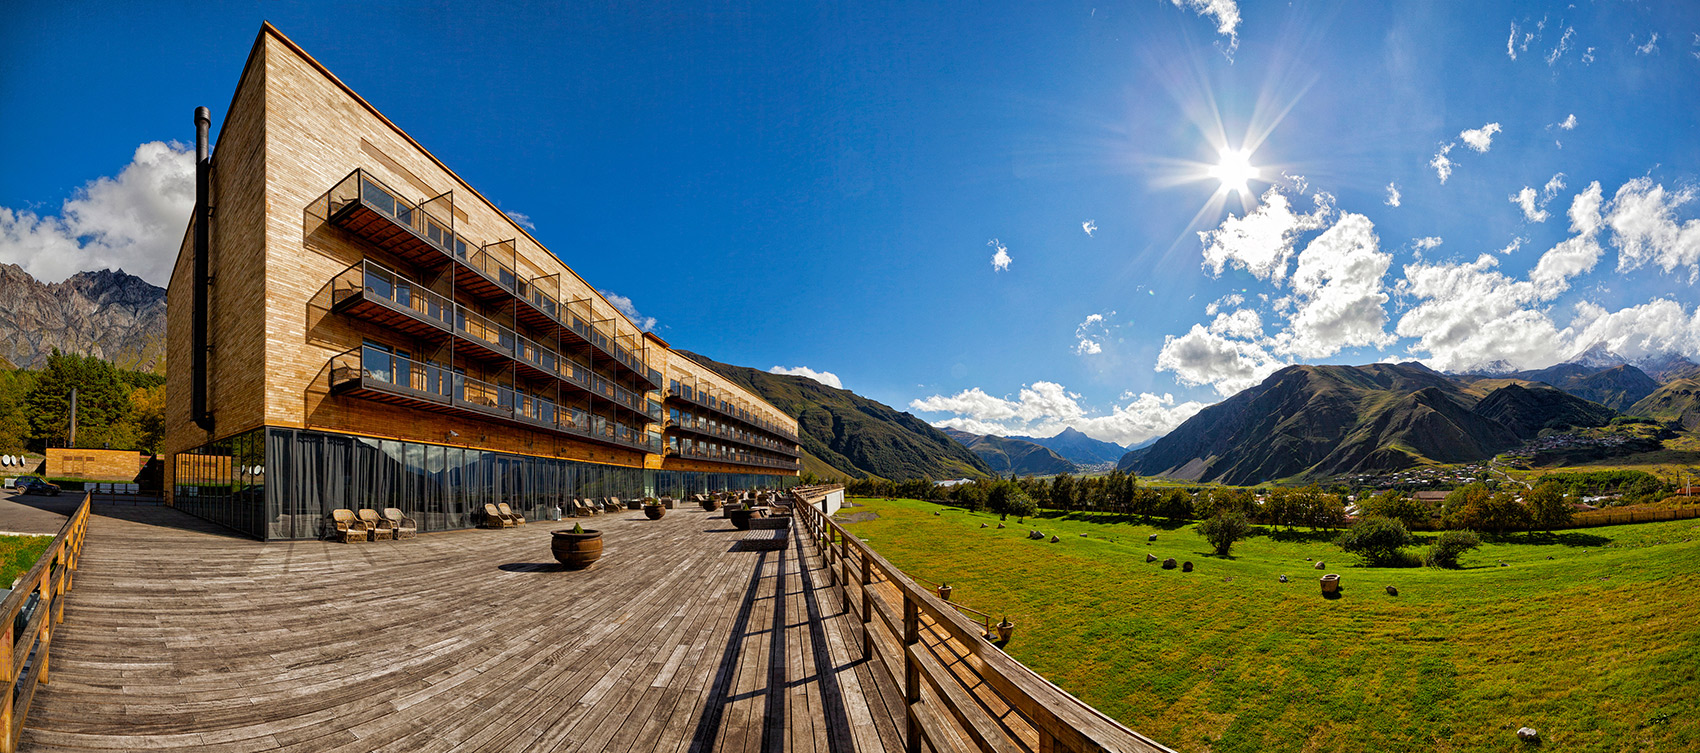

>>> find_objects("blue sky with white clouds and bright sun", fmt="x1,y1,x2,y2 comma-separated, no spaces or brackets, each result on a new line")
0,0,1700,444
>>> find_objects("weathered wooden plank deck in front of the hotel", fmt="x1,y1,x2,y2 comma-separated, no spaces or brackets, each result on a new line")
22,507,904,751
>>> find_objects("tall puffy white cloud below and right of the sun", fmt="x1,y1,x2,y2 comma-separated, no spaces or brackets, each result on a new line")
1273,212,1394,359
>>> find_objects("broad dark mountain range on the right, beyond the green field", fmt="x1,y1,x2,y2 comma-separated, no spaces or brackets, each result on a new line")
1117,357,1700,484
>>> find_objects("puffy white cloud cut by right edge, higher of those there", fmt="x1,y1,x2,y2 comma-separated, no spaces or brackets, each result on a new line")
1605,178,1700,272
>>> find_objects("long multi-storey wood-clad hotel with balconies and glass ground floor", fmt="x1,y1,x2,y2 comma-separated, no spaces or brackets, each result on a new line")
165,24,801,539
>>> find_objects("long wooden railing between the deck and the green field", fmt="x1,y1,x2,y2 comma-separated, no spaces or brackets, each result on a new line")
792,486,1171,753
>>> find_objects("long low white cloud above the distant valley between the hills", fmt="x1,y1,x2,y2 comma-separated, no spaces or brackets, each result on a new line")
910,382,1205,445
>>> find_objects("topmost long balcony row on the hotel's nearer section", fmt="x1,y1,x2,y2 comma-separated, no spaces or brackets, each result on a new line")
308,168,661,389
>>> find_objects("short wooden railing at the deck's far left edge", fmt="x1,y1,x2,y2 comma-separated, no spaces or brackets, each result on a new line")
0,495,88,753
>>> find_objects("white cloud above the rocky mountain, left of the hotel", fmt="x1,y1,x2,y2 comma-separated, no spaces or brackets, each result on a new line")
0,141,196,286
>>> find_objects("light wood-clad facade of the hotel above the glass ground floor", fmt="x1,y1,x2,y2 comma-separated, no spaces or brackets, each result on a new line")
165,24,801,537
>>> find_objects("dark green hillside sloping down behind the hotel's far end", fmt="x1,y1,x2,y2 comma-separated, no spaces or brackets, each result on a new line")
675,350,991,481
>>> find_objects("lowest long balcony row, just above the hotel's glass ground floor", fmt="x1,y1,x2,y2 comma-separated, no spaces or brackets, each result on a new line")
330,345,661,454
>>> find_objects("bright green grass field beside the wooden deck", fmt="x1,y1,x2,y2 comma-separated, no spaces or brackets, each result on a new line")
845,500,1700,751
